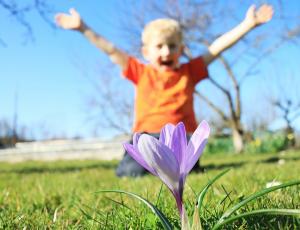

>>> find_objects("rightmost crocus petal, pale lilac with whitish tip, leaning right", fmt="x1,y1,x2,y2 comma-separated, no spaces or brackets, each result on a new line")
184,121,210,174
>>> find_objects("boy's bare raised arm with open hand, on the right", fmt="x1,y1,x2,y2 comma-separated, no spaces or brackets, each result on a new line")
203,4,273,65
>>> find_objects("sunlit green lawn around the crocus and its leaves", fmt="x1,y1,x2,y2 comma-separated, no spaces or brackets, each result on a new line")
0,152,300,229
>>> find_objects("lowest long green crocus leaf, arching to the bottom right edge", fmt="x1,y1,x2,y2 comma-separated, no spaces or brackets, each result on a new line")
213,209,300,230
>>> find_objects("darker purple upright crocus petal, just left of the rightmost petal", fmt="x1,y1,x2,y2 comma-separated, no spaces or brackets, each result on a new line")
171,122,187,169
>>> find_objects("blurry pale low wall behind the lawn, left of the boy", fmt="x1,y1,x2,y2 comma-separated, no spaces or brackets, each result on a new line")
0,136,129,162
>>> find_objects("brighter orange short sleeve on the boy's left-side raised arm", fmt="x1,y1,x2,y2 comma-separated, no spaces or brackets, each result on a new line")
122,56,145,84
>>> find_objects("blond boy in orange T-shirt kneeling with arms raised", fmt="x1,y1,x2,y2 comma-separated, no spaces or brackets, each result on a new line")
56,5,273,177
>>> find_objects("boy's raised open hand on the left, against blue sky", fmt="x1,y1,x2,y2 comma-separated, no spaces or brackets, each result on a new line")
55,8,82,30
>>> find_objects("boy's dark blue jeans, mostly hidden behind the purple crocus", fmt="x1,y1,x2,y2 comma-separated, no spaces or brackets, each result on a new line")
116,133,200,177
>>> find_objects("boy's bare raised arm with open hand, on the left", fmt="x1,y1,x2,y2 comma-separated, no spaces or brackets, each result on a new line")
55,9,128,69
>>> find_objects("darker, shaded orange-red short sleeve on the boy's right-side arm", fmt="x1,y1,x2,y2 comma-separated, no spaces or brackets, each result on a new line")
187,56,208,84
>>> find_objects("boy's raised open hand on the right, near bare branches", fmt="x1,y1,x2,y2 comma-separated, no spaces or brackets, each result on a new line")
245,4,273,27
